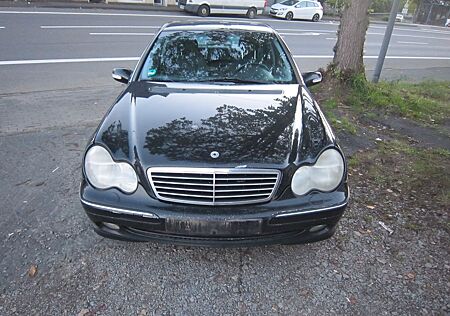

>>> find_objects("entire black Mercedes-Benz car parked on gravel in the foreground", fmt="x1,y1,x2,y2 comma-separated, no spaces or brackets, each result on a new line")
80,22,349,246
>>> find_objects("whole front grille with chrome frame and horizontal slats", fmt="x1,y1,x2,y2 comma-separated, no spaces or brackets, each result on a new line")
147,168,280,205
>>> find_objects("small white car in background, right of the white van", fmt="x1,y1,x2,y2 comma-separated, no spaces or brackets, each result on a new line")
270,0,323,22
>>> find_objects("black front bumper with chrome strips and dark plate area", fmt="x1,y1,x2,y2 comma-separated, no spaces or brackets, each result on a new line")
80,181,348,246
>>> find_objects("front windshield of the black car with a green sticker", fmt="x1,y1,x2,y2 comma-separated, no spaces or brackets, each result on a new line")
140,30,297,84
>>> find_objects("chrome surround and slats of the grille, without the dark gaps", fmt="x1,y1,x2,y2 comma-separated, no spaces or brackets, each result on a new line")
147,167,281,206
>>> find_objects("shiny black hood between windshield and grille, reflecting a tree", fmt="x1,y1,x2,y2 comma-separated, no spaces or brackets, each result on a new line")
94,82,324,170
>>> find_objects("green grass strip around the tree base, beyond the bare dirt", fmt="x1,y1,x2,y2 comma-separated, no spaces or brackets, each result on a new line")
312,71,450,127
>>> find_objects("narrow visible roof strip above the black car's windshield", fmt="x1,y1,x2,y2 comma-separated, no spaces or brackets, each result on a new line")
161,21,275,33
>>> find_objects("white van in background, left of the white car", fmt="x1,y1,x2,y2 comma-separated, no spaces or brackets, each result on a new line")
178,0,266,19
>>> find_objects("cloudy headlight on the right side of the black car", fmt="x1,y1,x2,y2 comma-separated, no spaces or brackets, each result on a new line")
291,149,344,195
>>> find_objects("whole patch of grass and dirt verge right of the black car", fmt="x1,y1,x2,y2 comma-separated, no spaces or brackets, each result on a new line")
312,71,450,234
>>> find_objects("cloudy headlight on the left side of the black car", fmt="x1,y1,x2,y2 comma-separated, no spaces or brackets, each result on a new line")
84,146,137,193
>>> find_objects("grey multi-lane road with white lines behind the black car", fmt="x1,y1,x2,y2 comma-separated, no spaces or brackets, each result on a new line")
0,8,450,93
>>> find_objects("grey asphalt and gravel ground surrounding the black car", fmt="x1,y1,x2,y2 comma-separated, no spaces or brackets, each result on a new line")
0,9,450,316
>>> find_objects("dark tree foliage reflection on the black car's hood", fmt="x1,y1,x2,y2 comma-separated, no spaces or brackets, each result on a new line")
144,98,296,163
